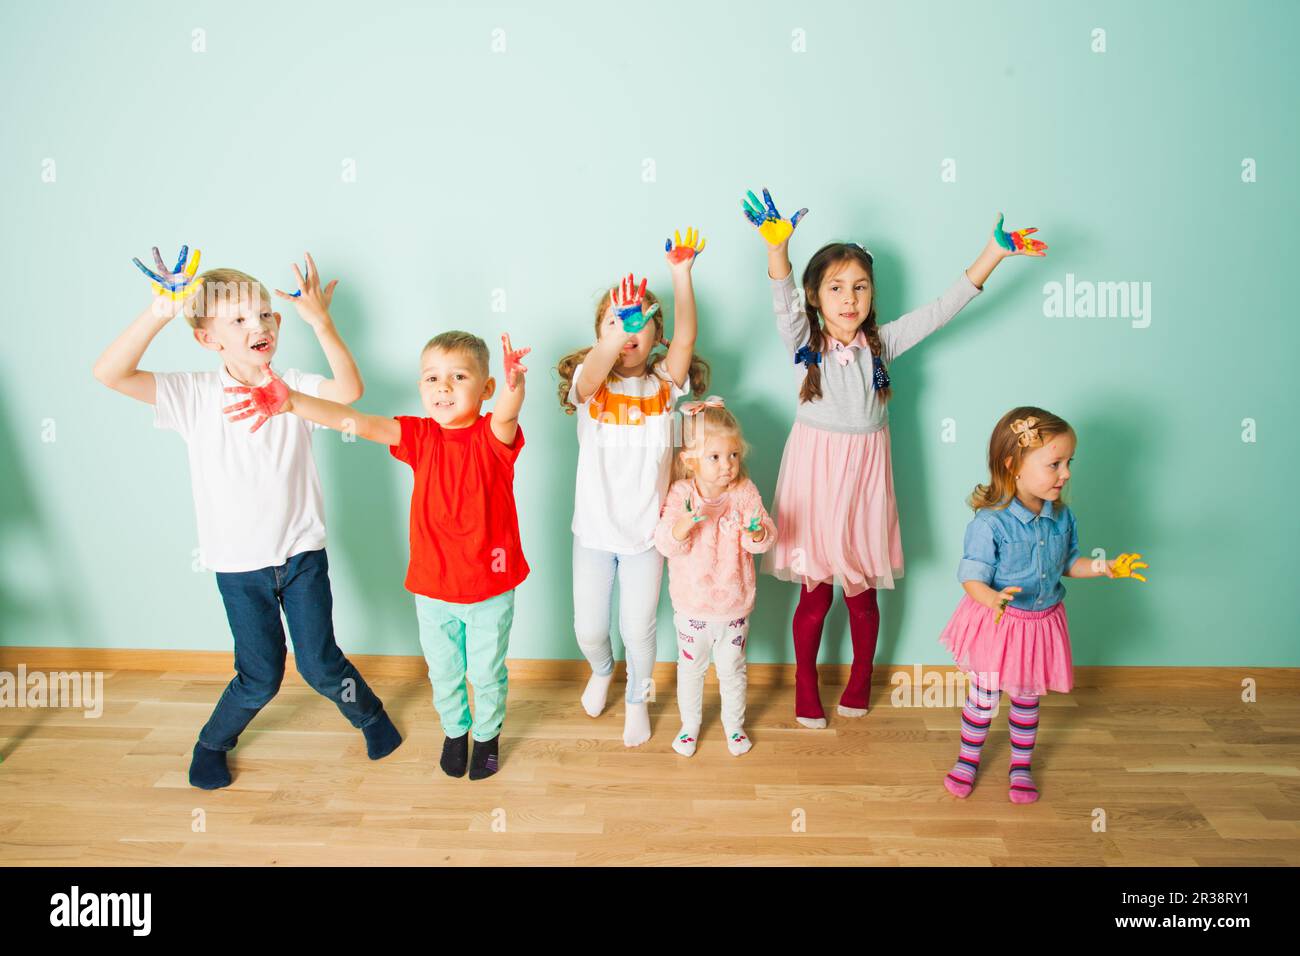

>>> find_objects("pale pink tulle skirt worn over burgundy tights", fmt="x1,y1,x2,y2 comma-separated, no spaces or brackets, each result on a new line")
763,421,902,597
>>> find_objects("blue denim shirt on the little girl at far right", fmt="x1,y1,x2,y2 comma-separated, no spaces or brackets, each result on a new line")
957,498,1079,611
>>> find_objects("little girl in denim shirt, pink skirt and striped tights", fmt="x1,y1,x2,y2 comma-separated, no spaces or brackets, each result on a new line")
940,406,1147,804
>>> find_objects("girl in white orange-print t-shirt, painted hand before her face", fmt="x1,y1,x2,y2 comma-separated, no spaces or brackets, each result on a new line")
556,230,709,747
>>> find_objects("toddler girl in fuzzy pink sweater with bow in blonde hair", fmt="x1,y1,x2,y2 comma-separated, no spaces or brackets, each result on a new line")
654,395,776,757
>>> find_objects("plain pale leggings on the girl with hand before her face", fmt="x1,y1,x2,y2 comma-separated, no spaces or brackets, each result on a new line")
573,537,663,704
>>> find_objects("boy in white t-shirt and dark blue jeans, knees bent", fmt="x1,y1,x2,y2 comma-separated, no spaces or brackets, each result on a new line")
95,248,402,790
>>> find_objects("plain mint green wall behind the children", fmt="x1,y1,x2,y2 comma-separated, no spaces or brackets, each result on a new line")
0,3,1300,666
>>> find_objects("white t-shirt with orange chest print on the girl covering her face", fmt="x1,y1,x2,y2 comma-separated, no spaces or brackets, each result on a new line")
569,364,686,554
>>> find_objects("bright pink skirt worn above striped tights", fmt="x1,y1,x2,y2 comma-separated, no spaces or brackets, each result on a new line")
939,594,1074,697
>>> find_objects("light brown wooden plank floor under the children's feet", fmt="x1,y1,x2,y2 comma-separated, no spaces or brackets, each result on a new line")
0,667,1300,866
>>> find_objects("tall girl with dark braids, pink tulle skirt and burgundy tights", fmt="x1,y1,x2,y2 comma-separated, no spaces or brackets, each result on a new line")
746,190,1047,727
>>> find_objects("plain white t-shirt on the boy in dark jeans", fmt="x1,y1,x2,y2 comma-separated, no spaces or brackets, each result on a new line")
153,368,325,571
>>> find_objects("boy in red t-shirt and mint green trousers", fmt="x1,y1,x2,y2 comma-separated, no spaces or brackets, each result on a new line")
230,332,529,780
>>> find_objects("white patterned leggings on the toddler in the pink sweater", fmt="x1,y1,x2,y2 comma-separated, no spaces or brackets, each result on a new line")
672,614,749,736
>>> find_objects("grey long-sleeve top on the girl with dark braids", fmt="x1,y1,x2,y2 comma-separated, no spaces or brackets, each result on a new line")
772,271,980,434
